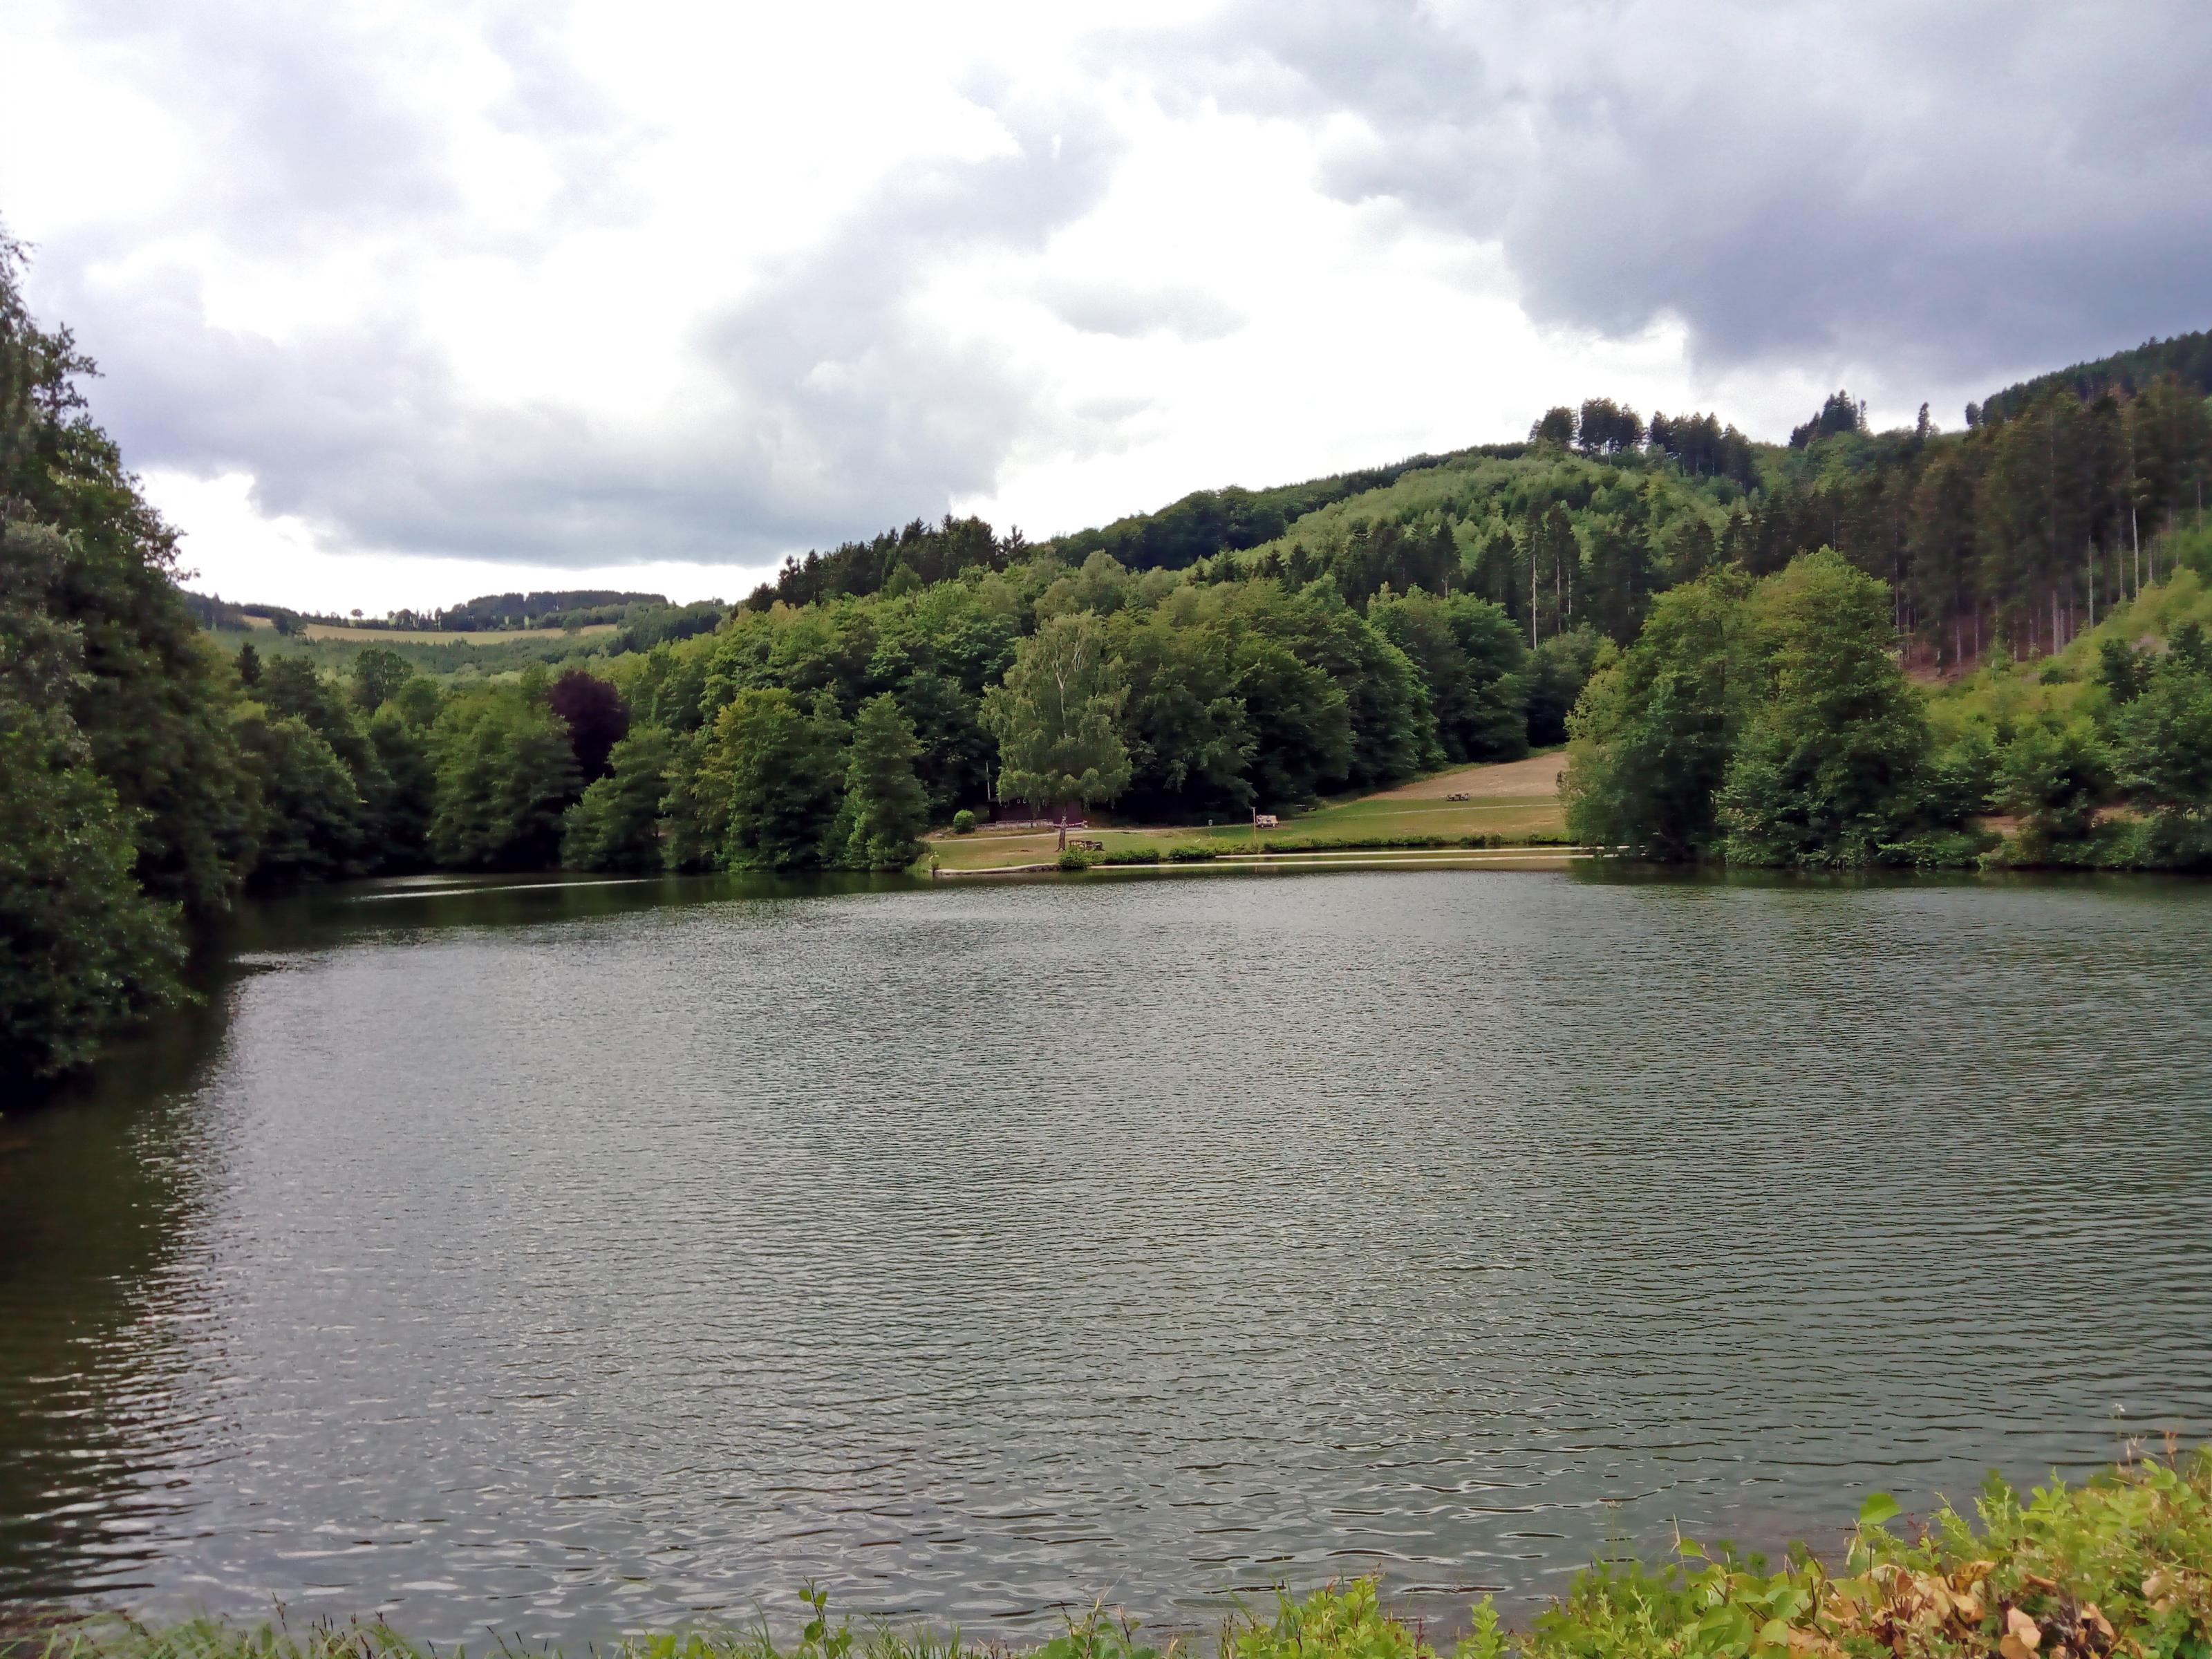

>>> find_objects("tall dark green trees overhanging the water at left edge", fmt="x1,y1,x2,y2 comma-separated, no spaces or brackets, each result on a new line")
0,236,227,1091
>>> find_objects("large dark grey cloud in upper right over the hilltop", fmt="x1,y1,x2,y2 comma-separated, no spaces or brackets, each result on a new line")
1139,0,2212,395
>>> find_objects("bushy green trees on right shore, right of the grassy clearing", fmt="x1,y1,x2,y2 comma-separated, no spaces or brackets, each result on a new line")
1564,549,2212,870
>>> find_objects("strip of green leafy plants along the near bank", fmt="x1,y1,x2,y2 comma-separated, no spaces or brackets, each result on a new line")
0,1449,2212,1659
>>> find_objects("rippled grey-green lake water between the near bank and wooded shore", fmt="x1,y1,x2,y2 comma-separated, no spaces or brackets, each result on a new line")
0,872,2212,1639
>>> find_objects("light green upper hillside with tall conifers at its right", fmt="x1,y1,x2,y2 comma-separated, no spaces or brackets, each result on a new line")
1230,380,2212,673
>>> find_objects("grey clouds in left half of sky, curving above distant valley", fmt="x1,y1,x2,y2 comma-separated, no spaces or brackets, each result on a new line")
33,7,1115,566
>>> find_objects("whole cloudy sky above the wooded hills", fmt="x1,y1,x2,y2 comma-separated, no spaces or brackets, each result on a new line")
0,0,2212,612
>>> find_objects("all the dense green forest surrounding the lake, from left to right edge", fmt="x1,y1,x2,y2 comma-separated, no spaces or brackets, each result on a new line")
12,236,2212,1080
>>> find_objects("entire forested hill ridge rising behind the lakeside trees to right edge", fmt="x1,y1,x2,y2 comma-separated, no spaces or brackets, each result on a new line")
745,345,2212,671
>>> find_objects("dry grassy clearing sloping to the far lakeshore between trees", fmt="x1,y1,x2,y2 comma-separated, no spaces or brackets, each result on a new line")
929,754,1566,885
